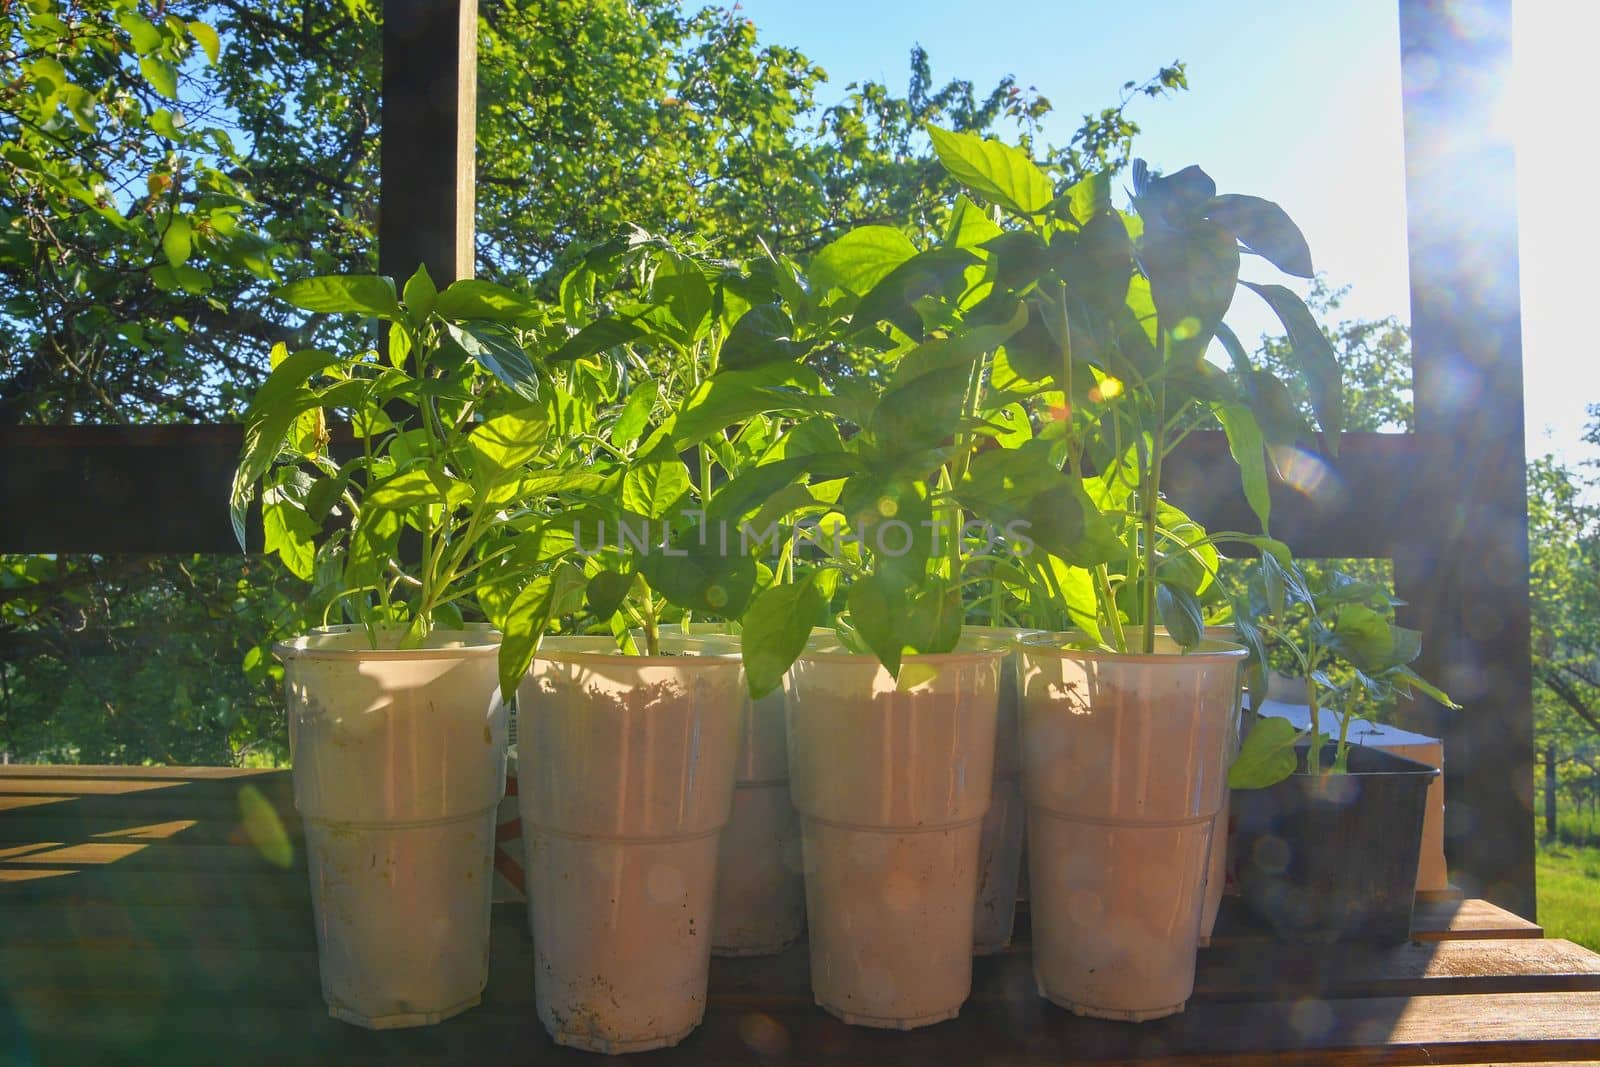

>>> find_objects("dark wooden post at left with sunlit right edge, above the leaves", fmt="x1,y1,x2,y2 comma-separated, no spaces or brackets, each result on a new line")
378,0,478,288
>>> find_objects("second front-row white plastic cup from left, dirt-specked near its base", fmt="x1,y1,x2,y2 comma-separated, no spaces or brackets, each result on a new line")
517,637,744,1054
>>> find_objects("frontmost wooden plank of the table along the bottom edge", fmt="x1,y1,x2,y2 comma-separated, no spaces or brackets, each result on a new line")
11,976,1600,1067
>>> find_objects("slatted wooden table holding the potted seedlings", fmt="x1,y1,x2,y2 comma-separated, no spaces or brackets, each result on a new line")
0,766,1600,1065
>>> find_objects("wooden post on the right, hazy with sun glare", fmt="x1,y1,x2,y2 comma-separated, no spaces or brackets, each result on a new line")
1395,0,1534,918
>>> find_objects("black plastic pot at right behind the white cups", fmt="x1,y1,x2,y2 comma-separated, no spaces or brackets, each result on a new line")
1234,745,1438,944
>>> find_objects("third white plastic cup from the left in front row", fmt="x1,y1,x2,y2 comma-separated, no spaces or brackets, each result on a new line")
784,641,1006,1030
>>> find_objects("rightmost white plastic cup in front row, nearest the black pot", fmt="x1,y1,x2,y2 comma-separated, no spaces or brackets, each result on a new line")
1021,637,1245,1022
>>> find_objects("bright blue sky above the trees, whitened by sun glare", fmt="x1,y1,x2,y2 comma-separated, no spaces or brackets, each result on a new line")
739,0,1600,461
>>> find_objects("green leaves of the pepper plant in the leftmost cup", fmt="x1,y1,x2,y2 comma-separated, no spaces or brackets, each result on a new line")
232,267,569,668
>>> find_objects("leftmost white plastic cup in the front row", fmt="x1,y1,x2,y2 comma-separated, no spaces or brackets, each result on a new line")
274,627,506,1030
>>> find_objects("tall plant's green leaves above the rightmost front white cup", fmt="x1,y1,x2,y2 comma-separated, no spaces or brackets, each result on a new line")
902,133,1342,651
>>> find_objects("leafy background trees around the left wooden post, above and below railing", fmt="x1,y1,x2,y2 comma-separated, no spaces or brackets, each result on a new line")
0,0,1186,761
